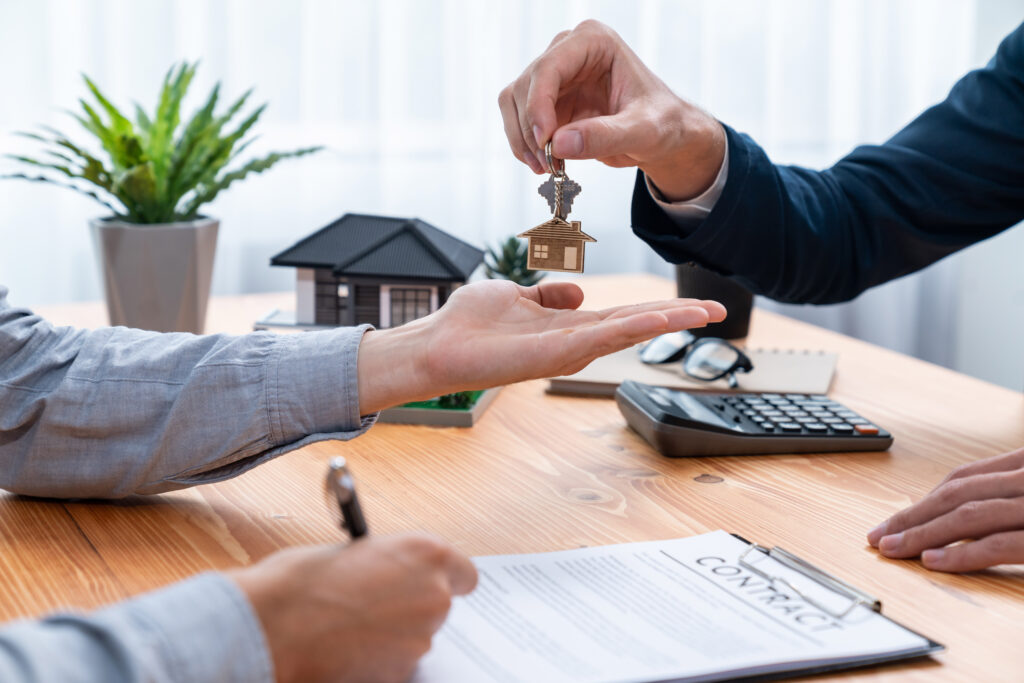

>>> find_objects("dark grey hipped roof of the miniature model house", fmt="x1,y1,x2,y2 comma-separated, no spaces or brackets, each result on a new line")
270,213,483,281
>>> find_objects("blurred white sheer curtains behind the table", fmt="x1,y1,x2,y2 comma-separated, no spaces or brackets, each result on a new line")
0,0,1024,390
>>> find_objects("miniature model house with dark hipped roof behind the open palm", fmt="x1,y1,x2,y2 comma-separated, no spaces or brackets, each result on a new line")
270,213,483,328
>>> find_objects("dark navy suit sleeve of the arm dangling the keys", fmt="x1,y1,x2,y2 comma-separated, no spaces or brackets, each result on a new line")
633,25,1024,303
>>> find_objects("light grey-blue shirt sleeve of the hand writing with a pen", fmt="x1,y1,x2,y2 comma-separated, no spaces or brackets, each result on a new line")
0,572,274,683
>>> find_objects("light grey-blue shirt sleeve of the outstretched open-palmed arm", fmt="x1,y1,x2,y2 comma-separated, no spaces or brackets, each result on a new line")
0,287,376,498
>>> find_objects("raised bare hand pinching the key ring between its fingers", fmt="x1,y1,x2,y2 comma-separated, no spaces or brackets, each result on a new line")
498,20,726,202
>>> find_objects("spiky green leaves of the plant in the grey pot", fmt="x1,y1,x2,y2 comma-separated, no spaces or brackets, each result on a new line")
0,62,321,223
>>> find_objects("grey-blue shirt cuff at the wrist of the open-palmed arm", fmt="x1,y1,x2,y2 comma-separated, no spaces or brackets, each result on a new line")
266,325,376,445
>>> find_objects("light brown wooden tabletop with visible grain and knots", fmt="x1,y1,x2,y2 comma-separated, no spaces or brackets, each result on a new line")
0,275,1024,681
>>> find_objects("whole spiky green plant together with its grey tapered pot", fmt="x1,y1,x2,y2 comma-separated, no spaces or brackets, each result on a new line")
3,62,321,333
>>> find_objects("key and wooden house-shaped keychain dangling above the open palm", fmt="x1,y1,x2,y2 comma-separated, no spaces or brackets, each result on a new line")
516,140,597,272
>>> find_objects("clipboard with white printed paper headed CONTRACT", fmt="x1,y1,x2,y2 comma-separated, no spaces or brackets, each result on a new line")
413,531,942,683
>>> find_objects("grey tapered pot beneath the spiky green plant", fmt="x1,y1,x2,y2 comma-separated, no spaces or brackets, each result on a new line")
89,218,220,334
